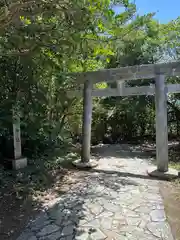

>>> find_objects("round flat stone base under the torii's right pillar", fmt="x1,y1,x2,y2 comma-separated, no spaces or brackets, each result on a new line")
147,167,179,180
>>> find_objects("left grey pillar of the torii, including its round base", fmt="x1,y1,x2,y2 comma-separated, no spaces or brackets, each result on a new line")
73,80,98,168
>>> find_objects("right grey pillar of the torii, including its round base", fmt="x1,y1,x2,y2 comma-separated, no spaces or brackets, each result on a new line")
148,74,178,180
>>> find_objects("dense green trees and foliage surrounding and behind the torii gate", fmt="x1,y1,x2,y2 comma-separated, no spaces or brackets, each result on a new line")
0,0,180,159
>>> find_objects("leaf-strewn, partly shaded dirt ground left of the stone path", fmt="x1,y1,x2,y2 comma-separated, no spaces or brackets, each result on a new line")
0,165,72,240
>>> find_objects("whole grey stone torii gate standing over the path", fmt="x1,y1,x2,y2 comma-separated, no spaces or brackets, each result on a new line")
71,62,180,177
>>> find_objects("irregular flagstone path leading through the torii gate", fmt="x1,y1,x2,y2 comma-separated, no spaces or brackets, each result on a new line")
17,145,173,240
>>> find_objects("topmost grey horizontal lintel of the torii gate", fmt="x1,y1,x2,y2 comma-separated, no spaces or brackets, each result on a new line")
71,62,180,83
